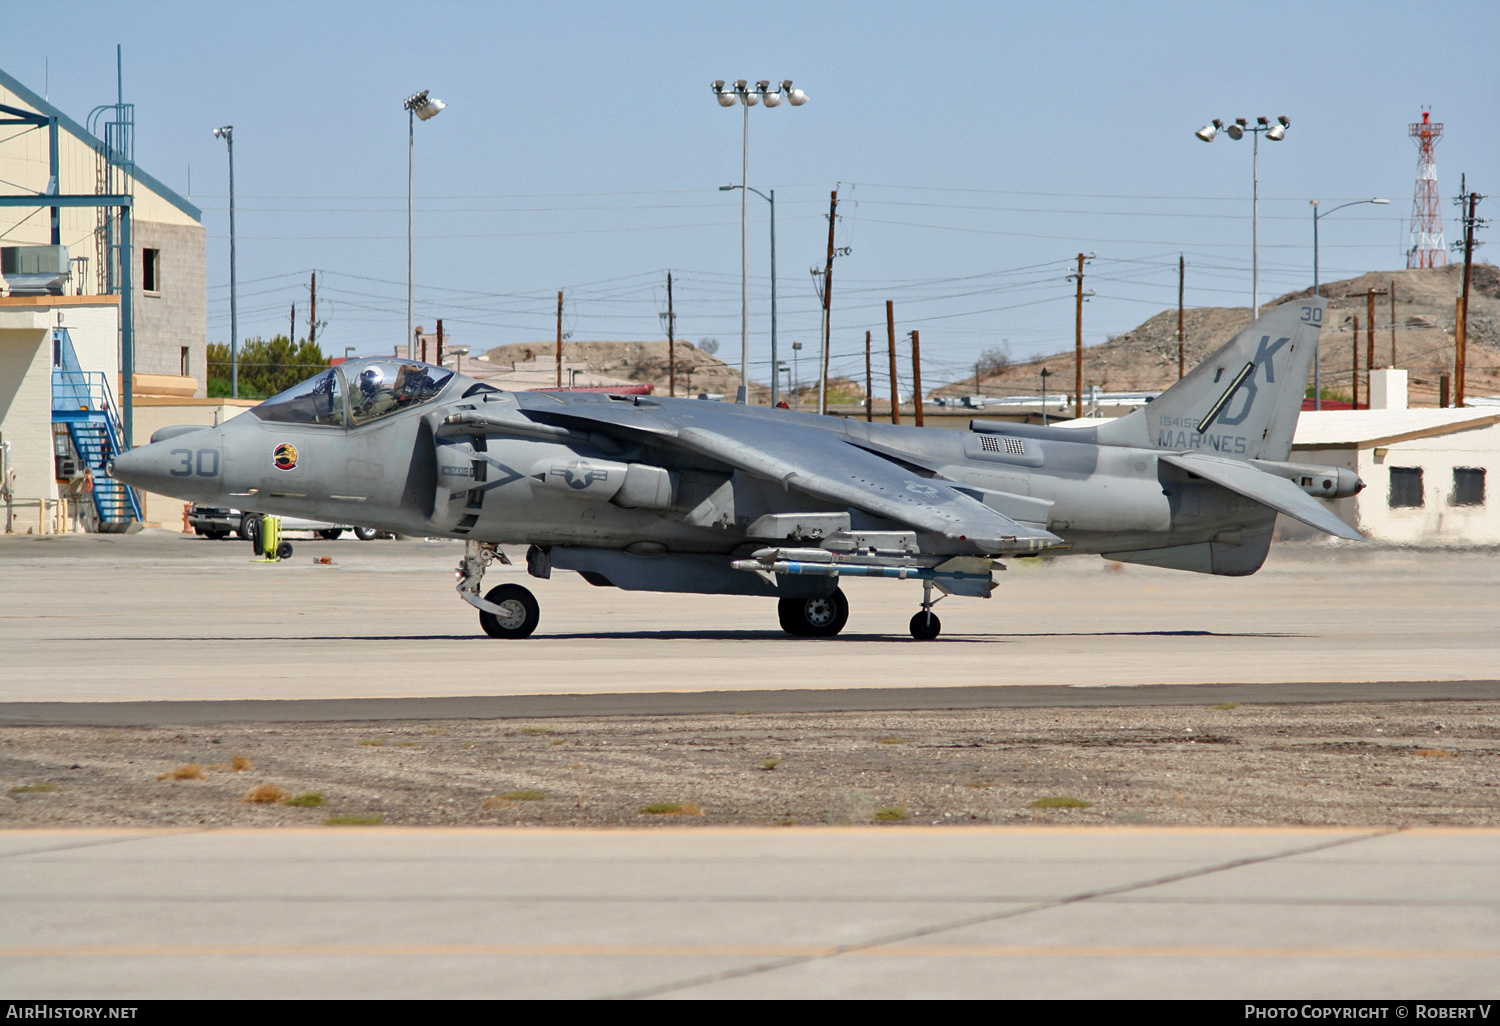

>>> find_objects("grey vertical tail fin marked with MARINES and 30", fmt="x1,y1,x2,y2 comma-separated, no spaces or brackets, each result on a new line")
1098,299,1328,461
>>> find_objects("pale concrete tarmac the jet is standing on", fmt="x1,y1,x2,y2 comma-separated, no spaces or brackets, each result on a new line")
0,531,1500,714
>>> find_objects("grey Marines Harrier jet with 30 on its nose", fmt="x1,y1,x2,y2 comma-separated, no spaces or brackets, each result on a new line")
113,299,1364,639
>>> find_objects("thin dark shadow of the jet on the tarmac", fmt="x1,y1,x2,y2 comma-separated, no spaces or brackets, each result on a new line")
73,630,1311,645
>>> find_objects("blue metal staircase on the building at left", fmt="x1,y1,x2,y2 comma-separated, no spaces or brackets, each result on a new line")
53,329,141,531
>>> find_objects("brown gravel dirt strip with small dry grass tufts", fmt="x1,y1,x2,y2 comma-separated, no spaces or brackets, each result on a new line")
0,702,1500,828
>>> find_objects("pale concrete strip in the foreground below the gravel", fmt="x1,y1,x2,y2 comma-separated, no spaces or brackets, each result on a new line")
0,827,1500,1002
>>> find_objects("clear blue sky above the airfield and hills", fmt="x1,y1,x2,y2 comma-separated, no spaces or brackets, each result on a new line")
0,0,1500,393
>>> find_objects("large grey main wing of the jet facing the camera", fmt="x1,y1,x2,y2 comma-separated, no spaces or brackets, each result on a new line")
522,404,1062,554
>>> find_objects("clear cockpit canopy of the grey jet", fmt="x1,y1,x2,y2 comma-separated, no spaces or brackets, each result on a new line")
251,360,453,428
